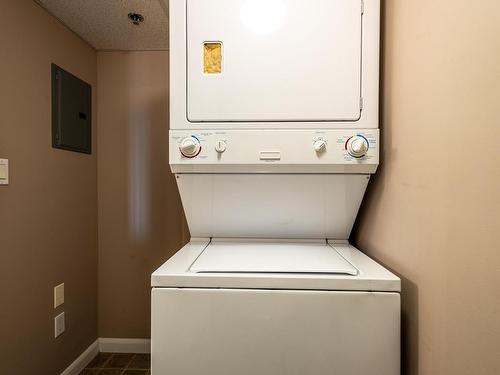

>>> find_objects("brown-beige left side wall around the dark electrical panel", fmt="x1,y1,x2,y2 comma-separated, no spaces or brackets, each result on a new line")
0,0,97,375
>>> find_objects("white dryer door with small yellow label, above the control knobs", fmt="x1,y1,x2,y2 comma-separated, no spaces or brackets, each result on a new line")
186,0,362,122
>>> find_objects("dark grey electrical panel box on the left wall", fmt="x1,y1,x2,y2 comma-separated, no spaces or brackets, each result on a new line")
52,64,92,154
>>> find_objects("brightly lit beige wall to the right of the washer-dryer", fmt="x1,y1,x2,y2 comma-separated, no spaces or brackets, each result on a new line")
353,0,500,375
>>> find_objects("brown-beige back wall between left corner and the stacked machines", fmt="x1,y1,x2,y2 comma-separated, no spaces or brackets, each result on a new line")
98,51,187,338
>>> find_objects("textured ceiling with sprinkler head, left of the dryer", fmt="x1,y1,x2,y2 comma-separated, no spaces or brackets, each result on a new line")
35,0,168,51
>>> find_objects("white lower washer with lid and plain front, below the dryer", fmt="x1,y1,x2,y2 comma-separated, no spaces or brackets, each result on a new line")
152,239,400,375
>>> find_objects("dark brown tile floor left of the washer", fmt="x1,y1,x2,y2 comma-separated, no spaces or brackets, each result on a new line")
80,353,151,375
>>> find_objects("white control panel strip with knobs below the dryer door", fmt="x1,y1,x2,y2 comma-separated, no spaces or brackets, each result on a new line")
170,129,379,173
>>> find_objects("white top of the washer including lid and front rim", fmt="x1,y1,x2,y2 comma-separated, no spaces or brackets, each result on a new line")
151,238,401,293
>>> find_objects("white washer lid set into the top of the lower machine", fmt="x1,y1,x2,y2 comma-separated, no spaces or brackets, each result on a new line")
190,241,358,276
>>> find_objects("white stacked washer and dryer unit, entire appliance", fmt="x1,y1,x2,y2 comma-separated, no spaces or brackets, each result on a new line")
151,0,400,375
